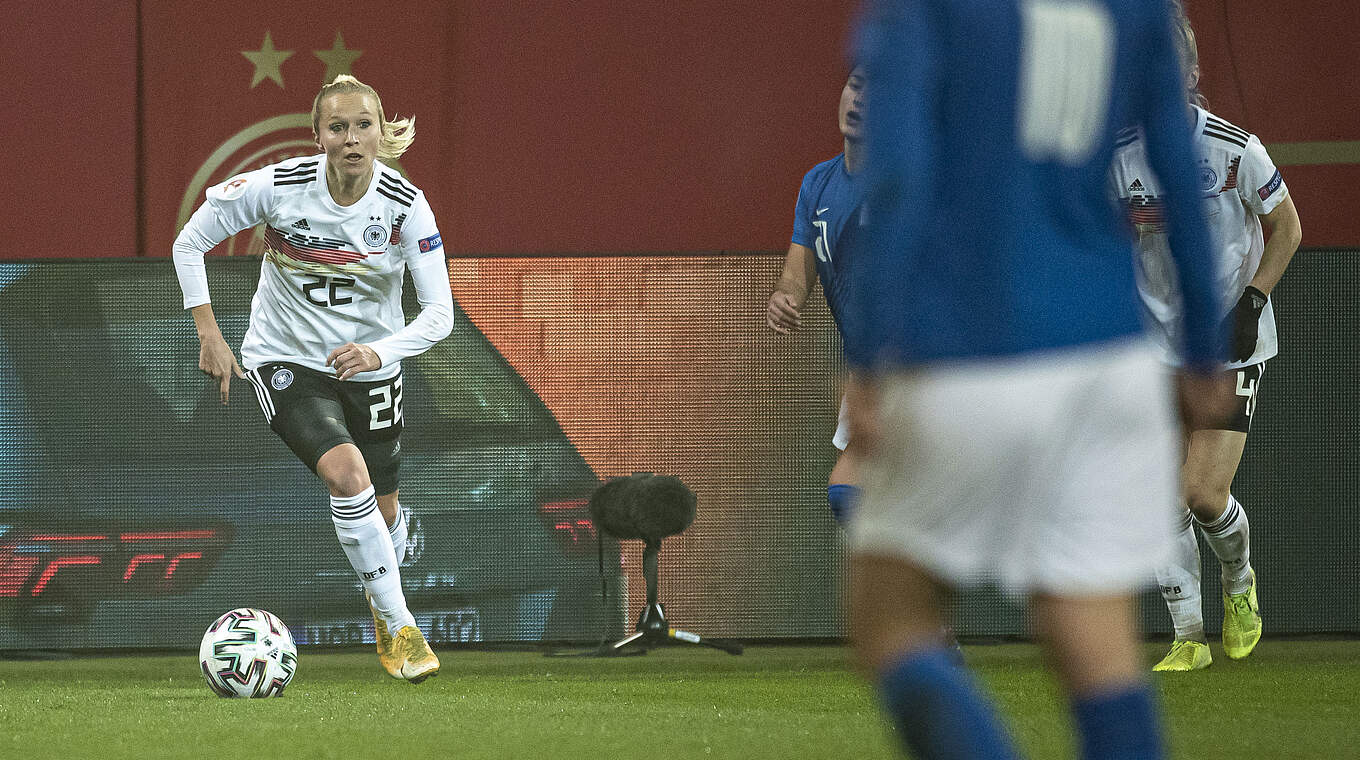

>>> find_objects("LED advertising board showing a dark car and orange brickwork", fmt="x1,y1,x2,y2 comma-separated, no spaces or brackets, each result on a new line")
0,252,1360,650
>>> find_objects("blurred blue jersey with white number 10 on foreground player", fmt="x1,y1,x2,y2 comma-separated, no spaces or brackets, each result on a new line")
842,0,1224,367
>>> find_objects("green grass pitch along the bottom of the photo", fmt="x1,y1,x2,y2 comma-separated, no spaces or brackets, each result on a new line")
0,640,1360,760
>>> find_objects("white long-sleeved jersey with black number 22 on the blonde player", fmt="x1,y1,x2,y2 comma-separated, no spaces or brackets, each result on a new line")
175,155,453,381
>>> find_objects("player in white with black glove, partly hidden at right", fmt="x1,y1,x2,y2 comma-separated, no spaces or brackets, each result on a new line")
1111,7,1302,670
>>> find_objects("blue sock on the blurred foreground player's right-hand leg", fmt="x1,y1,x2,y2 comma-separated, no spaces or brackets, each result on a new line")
1072,684,1166,760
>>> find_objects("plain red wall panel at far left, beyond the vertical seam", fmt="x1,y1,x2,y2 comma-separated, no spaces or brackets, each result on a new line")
0,0,140,258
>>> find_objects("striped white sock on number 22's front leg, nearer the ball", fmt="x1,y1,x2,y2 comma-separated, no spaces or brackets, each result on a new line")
330,485,415,634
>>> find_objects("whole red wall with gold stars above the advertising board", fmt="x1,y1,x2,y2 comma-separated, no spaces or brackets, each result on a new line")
0,0,1360,258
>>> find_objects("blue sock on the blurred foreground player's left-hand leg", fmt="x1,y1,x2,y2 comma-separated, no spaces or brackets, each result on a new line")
879,647,1019,760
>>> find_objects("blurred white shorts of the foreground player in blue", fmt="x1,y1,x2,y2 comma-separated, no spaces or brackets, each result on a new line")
849,339,1183,595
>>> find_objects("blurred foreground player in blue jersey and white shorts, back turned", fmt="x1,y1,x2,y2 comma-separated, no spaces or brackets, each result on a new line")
846,0,1225,759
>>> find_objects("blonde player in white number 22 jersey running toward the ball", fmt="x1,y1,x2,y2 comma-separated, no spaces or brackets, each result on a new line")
174,75,453,683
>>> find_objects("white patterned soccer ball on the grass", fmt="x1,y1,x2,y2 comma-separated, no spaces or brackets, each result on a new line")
199,606,298,697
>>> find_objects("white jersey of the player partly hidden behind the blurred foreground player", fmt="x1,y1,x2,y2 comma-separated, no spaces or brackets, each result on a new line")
1110,107,1289,367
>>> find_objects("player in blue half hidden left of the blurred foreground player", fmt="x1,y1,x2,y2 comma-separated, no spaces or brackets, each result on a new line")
766,67,865,523
